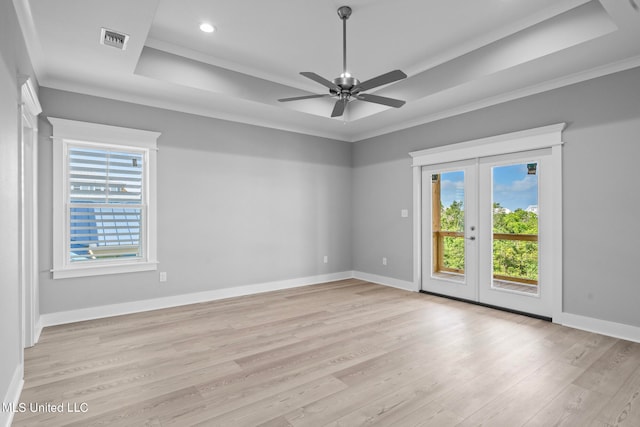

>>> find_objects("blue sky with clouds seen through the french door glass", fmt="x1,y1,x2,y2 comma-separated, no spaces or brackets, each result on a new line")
441,163,538,211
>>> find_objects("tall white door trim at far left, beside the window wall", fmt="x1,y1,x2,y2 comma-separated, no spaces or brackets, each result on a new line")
19,77,42,348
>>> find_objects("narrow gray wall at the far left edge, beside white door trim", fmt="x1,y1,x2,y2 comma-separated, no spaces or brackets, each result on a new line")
0,1,33,425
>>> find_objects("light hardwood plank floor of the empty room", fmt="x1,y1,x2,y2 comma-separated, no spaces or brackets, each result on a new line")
14,279,640,427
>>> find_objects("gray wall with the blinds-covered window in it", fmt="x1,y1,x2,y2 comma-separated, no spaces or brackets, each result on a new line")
39,87,352,313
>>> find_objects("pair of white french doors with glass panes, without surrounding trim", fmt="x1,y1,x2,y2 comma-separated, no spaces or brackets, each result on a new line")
421,149,554,317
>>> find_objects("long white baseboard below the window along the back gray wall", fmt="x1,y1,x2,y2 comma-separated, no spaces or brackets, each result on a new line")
40,271,353,328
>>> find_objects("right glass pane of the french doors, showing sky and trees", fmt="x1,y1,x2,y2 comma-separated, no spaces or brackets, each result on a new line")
492,162,539,295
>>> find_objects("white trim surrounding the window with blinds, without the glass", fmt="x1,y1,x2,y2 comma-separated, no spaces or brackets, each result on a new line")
48,117,160,279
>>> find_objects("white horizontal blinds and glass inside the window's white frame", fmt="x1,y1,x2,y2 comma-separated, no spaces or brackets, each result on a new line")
67,144,147,263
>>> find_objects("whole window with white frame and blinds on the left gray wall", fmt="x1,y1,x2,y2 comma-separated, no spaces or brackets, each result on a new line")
49,118,160,279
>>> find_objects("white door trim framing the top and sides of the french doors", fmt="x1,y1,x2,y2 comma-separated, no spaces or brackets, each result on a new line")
409,123,566,322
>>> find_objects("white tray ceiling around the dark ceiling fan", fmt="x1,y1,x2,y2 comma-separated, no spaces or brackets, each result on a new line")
14,0,640,141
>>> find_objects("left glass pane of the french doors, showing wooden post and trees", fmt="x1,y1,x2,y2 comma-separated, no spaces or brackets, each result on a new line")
431,171,465,281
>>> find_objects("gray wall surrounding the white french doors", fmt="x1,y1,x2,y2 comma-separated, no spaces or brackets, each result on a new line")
352,68,640,326
